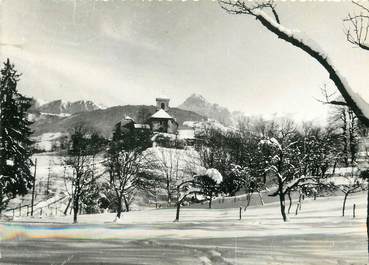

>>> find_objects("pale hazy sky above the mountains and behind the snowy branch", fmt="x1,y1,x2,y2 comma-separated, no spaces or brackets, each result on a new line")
0,0,369,120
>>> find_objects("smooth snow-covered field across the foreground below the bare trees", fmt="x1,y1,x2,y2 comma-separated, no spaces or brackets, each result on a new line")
0,193,368,265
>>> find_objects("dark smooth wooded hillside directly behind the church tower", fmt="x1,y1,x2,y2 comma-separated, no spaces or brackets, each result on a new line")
32,105,206,137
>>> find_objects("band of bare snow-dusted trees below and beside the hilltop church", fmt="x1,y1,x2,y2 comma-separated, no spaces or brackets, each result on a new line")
59,107,367,221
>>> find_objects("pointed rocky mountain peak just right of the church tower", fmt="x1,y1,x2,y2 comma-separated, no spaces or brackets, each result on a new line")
178,94,232,125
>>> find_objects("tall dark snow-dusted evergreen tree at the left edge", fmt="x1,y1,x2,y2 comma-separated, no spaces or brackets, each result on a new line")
0,59,32,210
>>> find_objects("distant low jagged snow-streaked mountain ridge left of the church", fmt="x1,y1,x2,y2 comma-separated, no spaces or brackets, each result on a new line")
37,100,100,115
